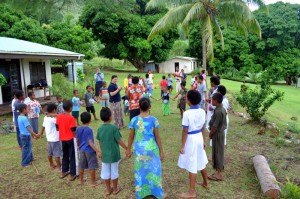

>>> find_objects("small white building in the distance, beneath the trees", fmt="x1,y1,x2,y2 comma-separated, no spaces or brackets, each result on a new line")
155,56,199,74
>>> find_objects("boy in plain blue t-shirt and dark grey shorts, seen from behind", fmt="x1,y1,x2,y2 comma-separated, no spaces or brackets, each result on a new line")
76,112,101,187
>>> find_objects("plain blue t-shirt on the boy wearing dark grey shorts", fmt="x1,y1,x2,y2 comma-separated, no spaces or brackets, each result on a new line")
76,126,95,152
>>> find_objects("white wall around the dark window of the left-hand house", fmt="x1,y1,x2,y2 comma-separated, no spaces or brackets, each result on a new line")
20,59,52,98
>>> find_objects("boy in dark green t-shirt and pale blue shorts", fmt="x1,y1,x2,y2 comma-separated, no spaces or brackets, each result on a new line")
97,108,127,196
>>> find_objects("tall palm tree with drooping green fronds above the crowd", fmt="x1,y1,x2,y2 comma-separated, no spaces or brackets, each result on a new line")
147,0,267,70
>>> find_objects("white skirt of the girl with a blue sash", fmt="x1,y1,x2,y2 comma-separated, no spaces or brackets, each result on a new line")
178,133,208,174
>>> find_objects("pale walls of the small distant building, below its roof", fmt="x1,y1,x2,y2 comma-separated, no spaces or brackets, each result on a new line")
159,59,198,73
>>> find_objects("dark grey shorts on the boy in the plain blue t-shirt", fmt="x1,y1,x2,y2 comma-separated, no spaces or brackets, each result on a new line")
79,151,99,169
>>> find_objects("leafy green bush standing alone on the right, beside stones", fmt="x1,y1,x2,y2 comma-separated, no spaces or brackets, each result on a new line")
236,75,284,121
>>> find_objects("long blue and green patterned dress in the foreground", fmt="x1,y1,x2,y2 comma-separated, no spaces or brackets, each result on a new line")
128,116,163,199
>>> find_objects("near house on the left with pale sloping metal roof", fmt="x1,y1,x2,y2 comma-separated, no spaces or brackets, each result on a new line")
0,37,84,104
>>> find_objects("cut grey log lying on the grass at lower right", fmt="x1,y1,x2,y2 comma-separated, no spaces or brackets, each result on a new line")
253,155,281,199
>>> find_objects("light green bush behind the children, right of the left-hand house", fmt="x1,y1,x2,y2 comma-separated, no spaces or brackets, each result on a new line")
51,73,88,100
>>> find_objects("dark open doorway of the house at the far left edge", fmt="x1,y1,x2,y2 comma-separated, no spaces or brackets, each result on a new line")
0,59,22,103
